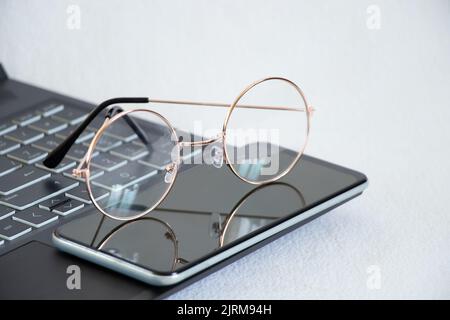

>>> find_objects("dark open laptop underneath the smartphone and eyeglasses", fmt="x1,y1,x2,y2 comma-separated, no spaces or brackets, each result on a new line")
0,64,367,299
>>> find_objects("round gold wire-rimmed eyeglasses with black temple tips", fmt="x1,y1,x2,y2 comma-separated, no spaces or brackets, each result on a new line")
44,77,314,220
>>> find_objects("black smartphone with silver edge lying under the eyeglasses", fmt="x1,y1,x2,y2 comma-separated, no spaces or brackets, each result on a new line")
53,155,368,286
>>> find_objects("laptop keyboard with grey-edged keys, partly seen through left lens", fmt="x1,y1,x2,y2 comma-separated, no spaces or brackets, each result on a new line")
0,102,197,249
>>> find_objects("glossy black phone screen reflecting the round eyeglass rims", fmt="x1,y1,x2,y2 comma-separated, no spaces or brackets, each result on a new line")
57,155,367,274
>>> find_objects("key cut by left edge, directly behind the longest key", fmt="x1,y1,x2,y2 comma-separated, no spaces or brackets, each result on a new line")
0,166,50,196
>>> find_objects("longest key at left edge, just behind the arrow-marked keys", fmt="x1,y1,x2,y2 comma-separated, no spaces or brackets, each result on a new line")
0,176,79,210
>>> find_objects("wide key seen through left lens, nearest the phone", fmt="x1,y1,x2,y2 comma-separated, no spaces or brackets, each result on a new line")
92,162,158,191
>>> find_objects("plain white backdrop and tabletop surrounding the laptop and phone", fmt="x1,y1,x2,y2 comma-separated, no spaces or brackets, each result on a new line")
0,0,450,298
